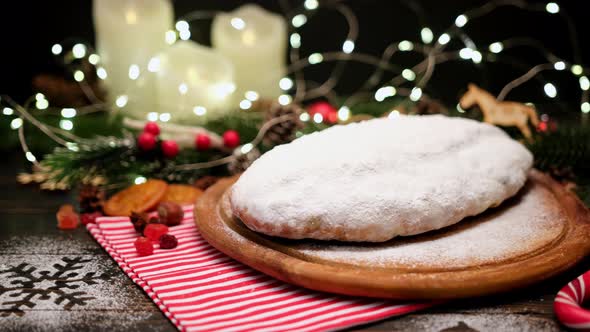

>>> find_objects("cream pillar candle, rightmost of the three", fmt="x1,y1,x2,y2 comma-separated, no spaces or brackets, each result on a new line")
211,4,287,100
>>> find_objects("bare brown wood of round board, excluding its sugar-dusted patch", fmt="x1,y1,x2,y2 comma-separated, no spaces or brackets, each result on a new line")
195,171,590,299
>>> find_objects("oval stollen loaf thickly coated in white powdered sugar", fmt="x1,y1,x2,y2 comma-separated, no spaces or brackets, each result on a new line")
231,115,533,242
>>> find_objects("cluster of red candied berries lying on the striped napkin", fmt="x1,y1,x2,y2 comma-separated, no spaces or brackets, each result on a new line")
130,202,184,256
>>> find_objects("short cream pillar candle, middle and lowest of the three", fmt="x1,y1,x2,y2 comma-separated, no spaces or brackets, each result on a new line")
155,41,235,123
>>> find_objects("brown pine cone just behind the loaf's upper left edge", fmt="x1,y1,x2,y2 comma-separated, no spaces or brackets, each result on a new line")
262,103,304,146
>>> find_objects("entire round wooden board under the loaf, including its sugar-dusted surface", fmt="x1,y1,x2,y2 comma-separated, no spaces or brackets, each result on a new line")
195,171,590,299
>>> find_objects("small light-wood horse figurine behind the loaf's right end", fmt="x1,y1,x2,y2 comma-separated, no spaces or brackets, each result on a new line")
459,83,539,141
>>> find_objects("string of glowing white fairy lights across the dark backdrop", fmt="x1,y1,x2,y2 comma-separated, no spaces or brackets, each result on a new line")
0,0,590,170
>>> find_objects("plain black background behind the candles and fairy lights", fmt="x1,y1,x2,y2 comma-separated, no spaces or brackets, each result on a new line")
0,0,590,112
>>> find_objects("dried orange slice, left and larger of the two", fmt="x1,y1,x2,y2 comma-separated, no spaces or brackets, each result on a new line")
103,179,168,216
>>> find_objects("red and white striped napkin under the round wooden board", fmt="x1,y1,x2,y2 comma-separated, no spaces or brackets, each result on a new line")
87,206,432,331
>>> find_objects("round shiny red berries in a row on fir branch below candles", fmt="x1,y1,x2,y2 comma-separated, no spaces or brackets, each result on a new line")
137,122,240,158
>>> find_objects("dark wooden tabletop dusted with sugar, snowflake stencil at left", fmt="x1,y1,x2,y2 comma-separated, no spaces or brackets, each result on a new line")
0,153,590,331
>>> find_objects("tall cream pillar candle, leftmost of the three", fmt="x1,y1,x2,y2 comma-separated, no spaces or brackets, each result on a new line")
93,0,175,118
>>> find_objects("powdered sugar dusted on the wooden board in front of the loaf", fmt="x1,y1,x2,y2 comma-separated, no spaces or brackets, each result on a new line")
292,185,567,269
